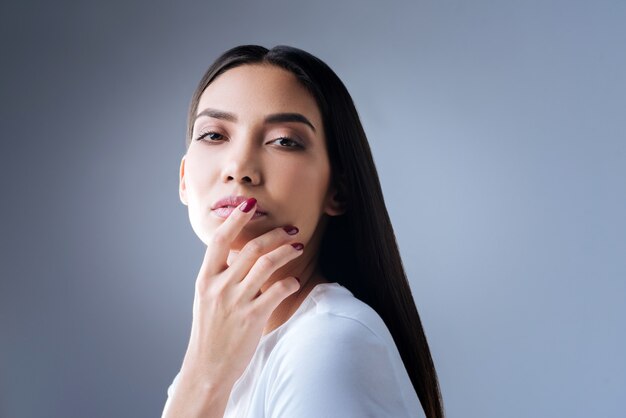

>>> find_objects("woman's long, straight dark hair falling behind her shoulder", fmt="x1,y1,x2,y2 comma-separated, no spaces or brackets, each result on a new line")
186,45,443,418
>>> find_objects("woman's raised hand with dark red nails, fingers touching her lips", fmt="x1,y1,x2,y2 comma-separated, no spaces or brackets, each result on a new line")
181,198,303,392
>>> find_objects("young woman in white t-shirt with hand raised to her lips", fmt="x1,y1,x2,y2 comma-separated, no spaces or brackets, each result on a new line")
163,45,443,418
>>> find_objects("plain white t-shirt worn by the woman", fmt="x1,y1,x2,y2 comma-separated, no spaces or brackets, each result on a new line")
165,282,424,418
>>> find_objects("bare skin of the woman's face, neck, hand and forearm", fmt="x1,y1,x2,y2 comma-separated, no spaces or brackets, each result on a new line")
163,65,344,418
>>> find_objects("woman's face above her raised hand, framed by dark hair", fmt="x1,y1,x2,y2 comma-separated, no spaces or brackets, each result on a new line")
179,64,340,258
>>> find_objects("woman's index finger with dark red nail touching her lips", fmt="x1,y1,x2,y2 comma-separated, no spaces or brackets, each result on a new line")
202,197,256,274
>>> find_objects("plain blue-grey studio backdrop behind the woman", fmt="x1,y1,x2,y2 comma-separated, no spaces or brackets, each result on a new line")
0,0,626,418
